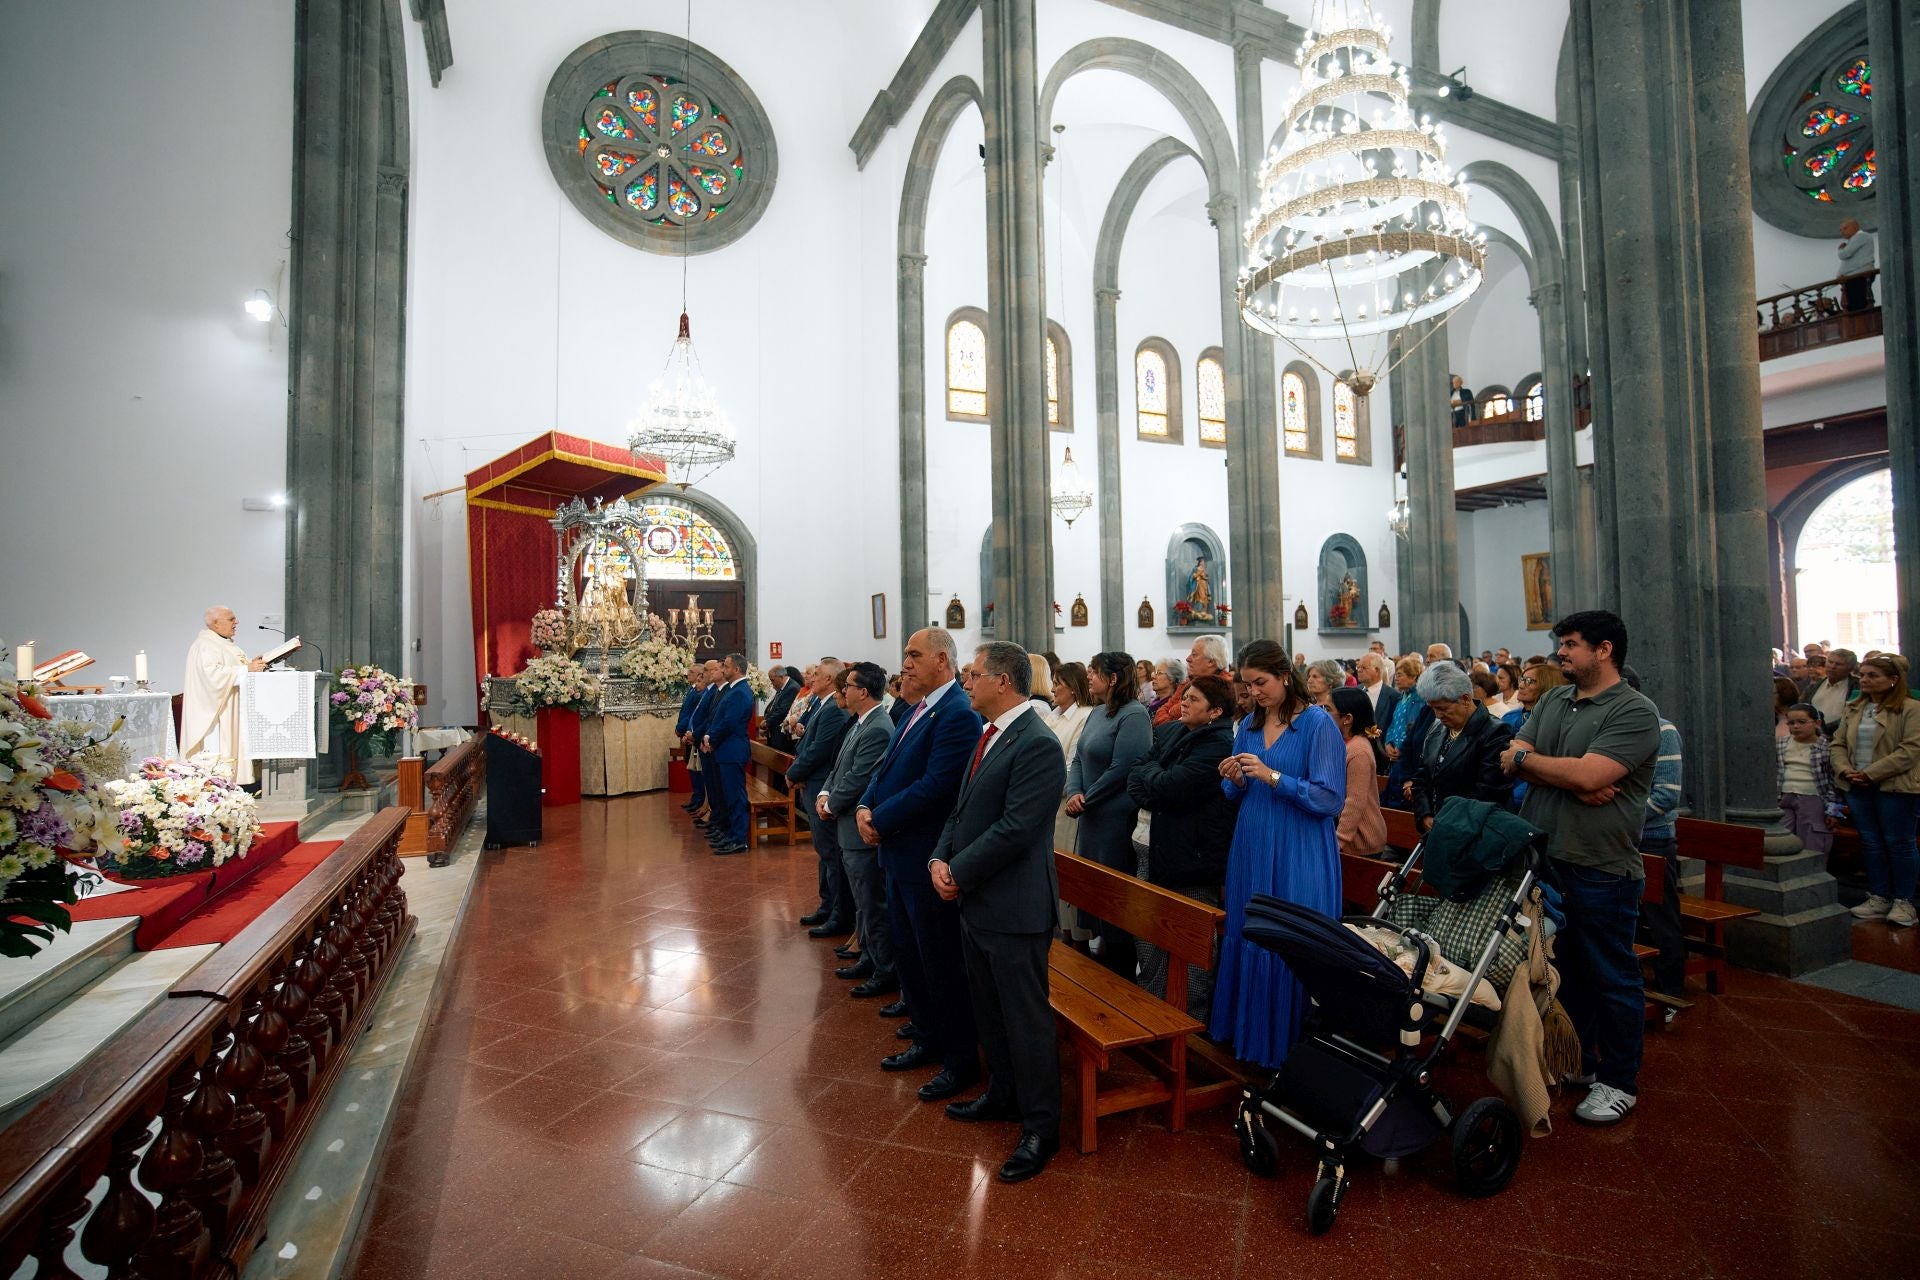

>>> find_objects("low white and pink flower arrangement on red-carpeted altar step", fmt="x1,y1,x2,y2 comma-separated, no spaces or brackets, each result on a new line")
100,756,259,881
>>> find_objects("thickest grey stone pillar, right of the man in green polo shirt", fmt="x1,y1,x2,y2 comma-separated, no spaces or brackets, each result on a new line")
1572,0,1847,973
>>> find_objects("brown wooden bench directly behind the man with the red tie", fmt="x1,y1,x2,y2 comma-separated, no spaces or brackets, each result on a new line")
1046,850,1240,1155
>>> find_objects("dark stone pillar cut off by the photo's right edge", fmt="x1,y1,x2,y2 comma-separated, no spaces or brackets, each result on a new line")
1866,0,1920,652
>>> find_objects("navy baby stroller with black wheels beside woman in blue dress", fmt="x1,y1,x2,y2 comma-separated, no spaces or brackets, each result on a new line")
1235,831,1546,1236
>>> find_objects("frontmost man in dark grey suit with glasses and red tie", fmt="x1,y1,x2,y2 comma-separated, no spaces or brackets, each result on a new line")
927,641,1068,1182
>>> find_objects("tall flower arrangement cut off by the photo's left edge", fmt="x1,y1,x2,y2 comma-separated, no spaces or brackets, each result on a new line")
0,660,127,956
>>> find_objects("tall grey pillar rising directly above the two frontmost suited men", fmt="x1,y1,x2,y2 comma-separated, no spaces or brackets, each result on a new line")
979,0,1054,651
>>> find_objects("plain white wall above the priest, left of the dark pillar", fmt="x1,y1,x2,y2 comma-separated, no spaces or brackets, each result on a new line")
0,0,294,691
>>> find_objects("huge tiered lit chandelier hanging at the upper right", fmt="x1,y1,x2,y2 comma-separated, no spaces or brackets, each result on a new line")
1238,0,1486,395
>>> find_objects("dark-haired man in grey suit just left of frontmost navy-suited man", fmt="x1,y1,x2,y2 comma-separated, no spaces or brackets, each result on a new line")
814,662,910,997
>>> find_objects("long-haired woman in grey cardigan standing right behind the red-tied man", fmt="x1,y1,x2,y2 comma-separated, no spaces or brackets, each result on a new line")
1068,652,1154,983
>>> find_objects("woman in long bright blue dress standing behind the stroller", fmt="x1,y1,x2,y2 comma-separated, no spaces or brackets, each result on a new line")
1208,641,1346,1067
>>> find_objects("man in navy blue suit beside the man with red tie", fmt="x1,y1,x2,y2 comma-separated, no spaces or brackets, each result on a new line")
854,628,981,1102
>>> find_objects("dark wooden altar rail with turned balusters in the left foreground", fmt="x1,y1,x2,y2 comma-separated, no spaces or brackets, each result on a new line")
0,806,415,1280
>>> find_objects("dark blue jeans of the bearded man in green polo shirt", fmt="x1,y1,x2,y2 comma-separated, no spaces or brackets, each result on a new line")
1553,860,1647,1094
